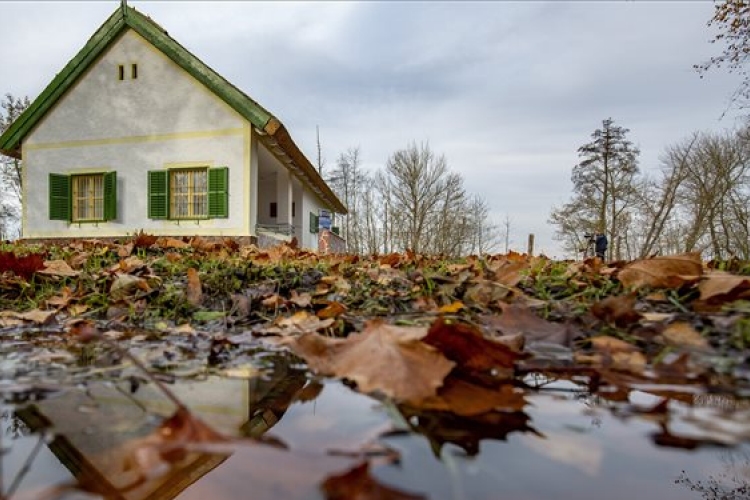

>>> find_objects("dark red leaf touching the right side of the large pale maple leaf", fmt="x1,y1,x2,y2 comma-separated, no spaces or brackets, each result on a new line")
423,318,522,381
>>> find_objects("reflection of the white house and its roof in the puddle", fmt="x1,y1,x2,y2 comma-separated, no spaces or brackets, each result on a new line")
18,362,307,500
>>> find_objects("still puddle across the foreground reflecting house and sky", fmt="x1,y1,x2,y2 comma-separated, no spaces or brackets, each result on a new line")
0,355,750,500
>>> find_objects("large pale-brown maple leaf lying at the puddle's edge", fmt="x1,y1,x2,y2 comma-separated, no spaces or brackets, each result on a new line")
289,320,455,401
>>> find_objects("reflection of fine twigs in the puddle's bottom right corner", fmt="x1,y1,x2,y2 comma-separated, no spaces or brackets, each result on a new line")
675,452,750,500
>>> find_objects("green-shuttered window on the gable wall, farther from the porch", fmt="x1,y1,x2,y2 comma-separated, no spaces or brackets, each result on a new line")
49,172,117,222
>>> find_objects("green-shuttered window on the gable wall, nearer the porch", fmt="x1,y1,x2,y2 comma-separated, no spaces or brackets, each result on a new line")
148,167,229,220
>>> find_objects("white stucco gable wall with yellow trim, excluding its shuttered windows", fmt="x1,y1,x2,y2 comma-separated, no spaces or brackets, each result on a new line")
23,31,254,238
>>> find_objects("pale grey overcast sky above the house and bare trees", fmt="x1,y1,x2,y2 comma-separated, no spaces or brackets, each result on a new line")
0,0,739,257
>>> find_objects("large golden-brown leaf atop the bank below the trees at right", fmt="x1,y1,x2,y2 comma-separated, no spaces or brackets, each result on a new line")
617,252,703,288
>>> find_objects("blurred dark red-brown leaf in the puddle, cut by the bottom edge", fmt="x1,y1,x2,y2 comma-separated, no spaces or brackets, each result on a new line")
320,462,427,500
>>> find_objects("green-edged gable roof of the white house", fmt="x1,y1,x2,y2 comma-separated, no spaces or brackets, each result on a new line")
0,5,346,213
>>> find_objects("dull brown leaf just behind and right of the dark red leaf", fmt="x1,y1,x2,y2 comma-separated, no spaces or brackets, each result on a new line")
480,302,572,346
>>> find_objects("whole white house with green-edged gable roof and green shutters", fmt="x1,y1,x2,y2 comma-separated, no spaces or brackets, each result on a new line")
0,3,346,248
